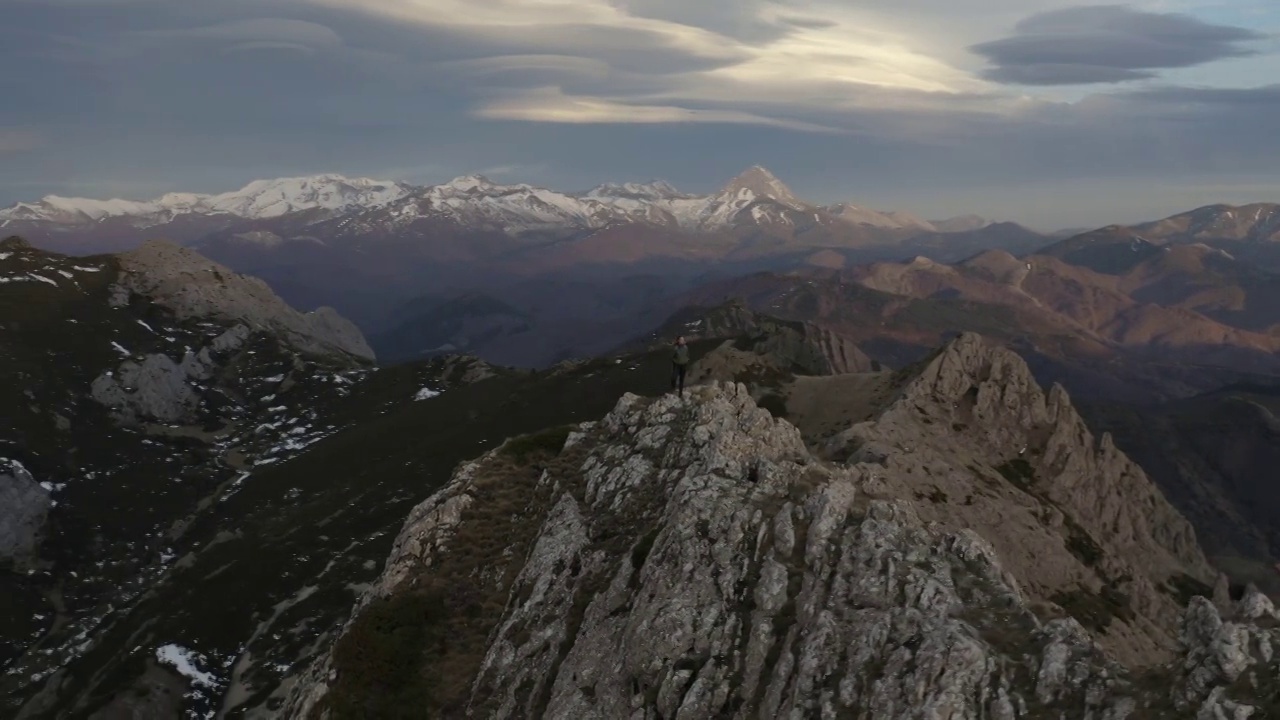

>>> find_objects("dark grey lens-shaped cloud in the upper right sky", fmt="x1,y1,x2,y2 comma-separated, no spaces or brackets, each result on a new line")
972,5,1267,86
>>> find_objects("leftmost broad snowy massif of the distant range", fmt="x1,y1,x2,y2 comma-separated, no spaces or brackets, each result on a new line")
0,174,412,227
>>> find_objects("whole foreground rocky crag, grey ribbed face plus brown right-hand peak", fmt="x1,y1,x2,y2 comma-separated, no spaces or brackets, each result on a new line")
282,336,1280,720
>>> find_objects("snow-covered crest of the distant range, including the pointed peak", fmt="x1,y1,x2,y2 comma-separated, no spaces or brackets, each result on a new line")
0,165,986,240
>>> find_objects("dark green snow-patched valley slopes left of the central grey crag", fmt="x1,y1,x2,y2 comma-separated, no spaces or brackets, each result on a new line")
0,267,747,717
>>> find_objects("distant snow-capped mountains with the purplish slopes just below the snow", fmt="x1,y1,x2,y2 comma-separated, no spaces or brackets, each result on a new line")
0,165,1018,260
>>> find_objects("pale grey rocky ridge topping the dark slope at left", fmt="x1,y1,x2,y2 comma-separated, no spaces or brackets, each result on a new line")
115,240,374,361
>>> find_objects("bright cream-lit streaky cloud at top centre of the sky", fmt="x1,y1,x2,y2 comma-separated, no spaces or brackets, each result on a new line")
314,0,987,120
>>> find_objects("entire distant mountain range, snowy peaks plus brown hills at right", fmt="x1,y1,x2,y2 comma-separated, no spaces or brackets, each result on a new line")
0,167,1280,370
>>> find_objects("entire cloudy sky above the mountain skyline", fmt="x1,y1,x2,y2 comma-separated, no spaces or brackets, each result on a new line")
0,0,1280,229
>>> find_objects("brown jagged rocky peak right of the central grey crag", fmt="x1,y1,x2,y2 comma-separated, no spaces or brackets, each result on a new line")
828,333,1216,665
